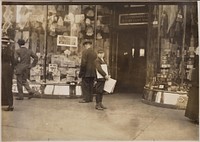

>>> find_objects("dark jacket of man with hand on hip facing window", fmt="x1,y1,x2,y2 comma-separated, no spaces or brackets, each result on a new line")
15,47,38,74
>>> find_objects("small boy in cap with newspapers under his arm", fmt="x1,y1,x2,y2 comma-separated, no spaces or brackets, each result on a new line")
95,49,110,110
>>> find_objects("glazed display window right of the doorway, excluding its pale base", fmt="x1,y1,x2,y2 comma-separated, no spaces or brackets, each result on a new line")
145,5,198,93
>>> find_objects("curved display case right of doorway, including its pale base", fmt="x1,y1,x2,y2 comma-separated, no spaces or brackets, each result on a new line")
143,5,198,109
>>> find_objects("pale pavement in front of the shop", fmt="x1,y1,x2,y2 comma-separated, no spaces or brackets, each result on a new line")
1,93,199,141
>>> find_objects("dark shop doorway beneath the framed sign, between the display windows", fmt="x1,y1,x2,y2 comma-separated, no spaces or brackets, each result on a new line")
116,28,147,93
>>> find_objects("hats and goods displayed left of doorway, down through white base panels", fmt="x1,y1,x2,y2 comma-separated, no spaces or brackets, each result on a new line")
8,5,110,95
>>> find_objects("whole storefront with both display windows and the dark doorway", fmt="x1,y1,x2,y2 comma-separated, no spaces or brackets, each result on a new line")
2,2,198,108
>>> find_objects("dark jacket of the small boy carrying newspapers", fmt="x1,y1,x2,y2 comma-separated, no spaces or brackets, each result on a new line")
95,58,109,81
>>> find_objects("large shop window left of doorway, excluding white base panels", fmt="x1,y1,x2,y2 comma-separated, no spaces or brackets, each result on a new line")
2,4,112,84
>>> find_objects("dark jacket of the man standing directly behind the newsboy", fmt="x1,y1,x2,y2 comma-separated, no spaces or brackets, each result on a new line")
79,48,97,78
